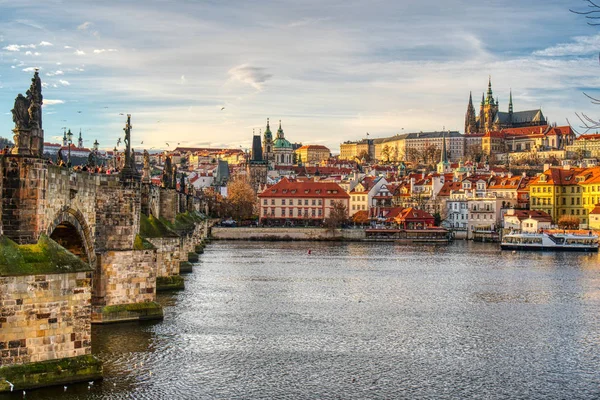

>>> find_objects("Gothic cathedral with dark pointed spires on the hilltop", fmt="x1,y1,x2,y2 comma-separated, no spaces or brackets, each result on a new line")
465,78,547,135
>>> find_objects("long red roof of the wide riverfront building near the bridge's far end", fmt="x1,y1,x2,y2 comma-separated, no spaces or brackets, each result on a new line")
258,178,350,199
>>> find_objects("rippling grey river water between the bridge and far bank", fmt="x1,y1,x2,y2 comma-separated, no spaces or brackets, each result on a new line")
3,241,600,400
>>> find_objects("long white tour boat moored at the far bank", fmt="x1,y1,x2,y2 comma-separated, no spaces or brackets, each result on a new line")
500,232,598,252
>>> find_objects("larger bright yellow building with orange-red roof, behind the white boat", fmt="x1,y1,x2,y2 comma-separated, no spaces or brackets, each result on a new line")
529,168,587,224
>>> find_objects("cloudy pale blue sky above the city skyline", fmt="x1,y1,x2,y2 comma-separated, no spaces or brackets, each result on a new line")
0,0,600,153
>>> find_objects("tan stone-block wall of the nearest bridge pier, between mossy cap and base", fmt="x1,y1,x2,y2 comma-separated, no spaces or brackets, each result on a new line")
0,272,92,366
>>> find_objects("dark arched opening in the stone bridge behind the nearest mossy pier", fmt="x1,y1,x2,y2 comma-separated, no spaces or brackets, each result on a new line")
46,206,96,267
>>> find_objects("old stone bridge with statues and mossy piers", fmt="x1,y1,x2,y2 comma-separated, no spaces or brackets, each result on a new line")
0,72,208,392
